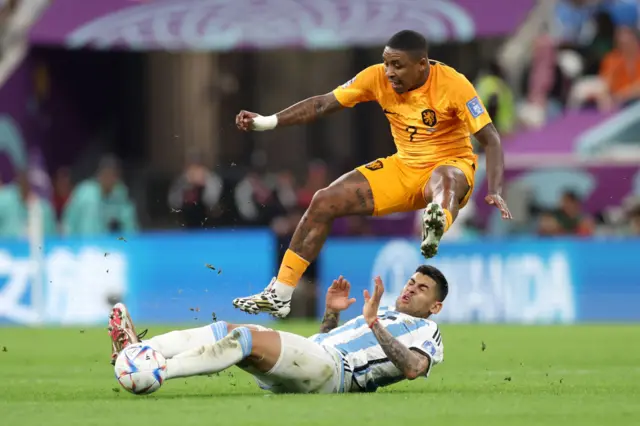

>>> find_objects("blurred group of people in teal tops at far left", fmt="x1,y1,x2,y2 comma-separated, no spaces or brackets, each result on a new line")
0,156,138,238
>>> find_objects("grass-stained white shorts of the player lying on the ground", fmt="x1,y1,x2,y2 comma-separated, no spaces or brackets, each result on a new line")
248,331,345,393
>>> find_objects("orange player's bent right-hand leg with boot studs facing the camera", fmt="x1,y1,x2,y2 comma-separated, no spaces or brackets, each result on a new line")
420,160,475,258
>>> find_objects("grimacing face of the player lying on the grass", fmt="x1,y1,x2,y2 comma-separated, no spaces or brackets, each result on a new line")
396,272,442,318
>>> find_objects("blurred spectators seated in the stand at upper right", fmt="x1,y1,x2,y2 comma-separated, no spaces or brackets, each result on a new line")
475,0,640,135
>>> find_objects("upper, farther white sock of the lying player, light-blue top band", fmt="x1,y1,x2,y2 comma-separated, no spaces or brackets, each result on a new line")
144,321,227,359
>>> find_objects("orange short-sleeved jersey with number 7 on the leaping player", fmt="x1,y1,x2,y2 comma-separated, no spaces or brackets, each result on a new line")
333,61,491,167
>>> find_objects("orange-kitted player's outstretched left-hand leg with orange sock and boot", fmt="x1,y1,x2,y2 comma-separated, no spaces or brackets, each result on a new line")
233,170,374,318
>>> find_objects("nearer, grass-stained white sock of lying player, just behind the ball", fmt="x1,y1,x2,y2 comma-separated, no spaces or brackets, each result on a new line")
167,327,252,379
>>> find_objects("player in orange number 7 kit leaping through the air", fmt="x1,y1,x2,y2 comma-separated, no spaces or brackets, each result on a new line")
233,31,511,318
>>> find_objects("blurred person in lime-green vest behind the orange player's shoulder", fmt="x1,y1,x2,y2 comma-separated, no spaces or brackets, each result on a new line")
475,60,516,136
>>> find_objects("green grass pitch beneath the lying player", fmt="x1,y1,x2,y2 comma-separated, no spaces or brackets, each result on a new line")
0,324,640,426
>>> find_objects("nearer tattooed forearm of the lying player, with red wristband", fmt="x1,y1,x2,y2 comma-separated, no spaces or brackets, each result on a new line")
371,322,430,380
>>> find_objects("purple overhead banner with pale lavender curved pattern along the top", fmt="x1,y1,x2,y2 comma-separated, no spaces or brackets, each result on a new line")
31,0,535,49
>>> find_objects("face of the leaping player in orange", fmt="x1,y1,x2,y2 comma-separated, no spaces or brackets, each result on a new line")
382,47,427,94
